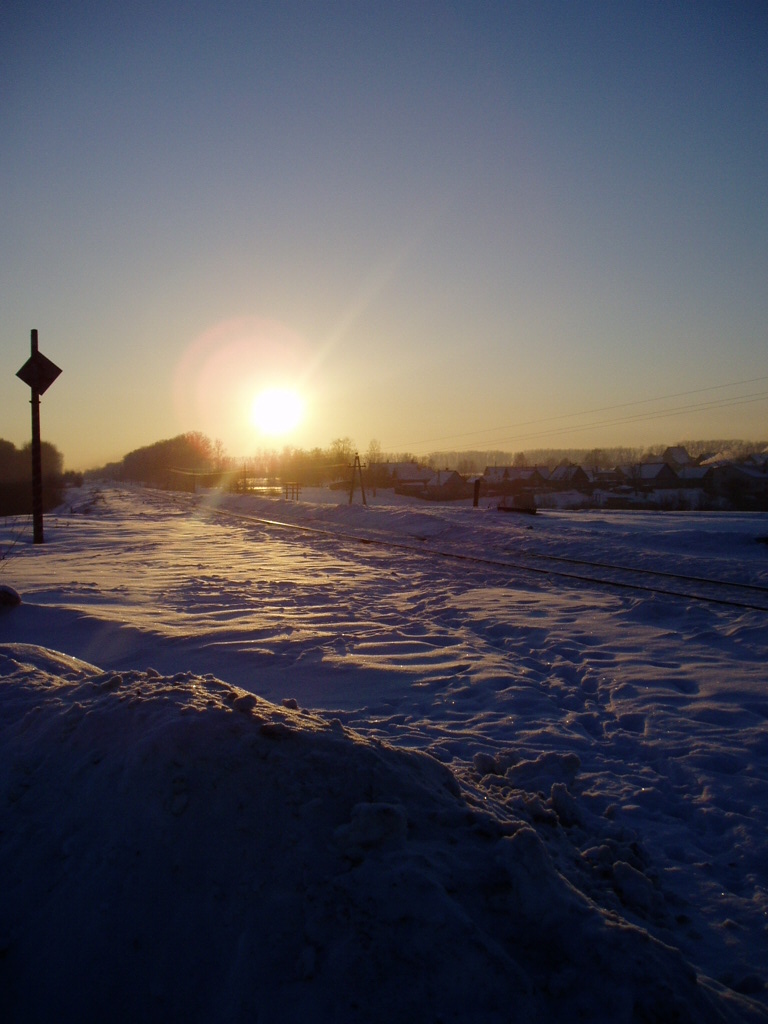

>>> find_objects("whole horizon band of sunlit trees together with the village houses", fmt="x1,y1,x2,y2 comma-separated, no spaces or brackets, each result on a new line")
79,433,768,512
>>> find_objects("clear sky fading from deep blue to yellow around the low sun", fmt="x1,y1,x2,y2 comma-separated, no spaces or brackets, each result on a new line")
0,0,768,469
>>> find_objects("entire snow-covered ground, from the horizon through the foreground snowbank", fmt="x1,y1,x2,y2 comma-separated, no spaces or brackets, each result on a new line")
0,484,768,1024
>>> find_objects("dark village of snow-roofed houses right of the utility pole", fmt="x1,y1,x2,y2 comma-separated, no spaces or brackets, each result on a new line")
367,446,768,511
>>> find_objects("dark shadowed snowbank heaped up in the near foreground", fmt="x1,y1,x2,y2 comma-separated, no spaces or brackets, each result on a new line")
0,645,759,1022
